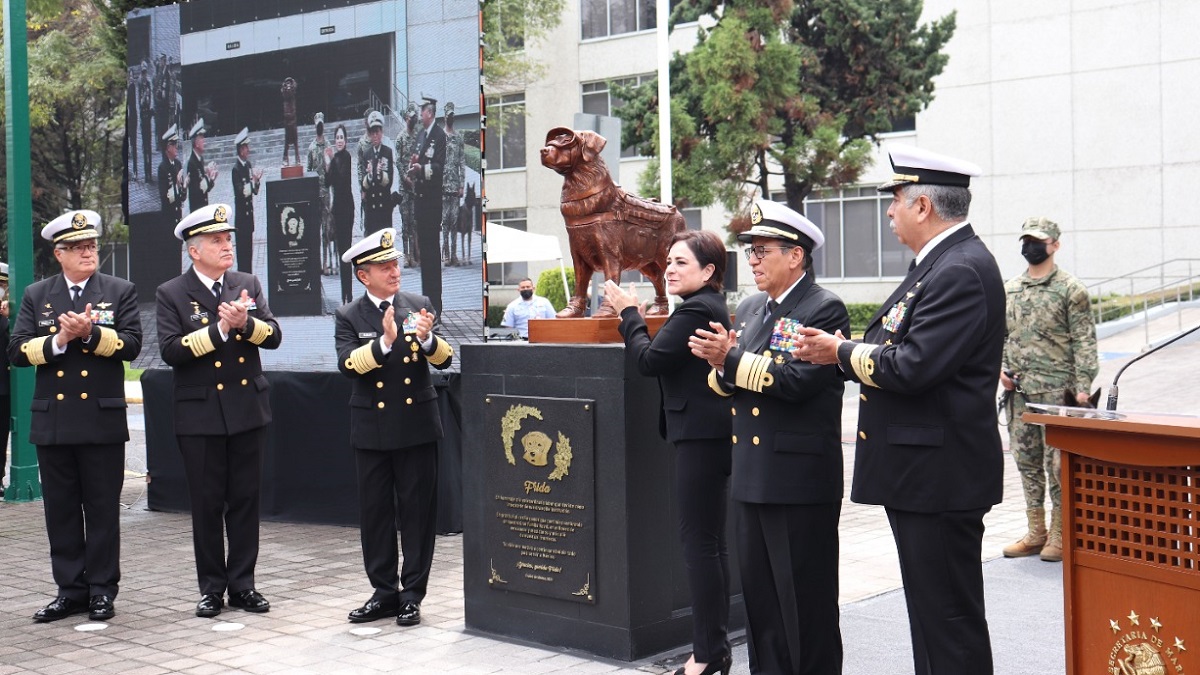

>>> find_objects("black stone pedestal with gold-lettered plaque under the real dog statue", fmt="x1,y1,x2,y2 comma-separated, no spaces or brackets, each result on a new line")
461,342,744,661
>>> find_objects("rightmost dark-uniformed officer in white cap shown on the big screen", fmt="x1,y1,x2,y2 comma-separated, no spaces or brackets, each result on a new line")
404,96,446,311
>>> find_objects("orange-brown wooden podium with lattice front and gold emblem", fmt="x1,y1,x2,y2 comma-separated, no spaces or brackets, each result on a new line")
1025,408,1200,675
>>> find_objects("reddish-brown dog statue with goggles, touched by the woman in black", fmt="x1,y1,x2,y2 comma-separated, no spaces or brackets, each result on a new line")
541,126,685,318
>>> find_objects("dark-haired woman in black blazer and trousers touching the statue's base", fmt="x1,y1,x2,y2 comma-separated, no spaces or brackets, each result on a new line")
605,231,732,675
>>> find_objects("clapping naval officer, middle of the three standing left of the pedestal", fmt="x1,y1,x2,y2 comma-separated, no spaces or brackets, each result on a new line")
156,204,283,616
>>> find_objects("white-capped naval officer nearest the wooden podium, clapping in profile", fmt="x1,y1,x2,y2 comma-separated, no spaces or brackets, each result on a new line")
796,147,1004,675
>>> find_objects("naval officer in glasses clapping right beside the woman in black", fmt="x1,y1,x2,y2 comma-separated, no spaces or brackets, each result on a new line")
690,199,850,675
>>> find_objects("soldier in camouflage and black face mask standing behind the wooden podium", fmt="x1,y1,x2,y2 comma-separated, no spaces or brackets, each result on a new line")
1000,217,1099,562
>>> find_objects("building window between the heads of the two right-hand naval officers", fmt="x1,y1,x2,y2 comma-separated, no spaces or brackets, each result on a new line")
804,186,913,279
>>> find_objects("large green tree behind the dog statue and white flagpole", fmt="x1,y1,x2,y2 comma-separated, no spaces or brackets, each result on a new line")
616,0,955,231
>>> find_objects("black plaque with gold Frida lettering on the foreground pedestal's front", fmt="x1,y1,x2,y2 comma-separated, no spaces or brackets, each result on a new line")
482,394,596,603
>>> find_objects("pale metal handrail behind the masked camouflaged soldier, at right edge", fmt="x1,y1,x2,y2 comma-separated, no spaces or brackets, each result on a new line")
1087,258,1200,345
